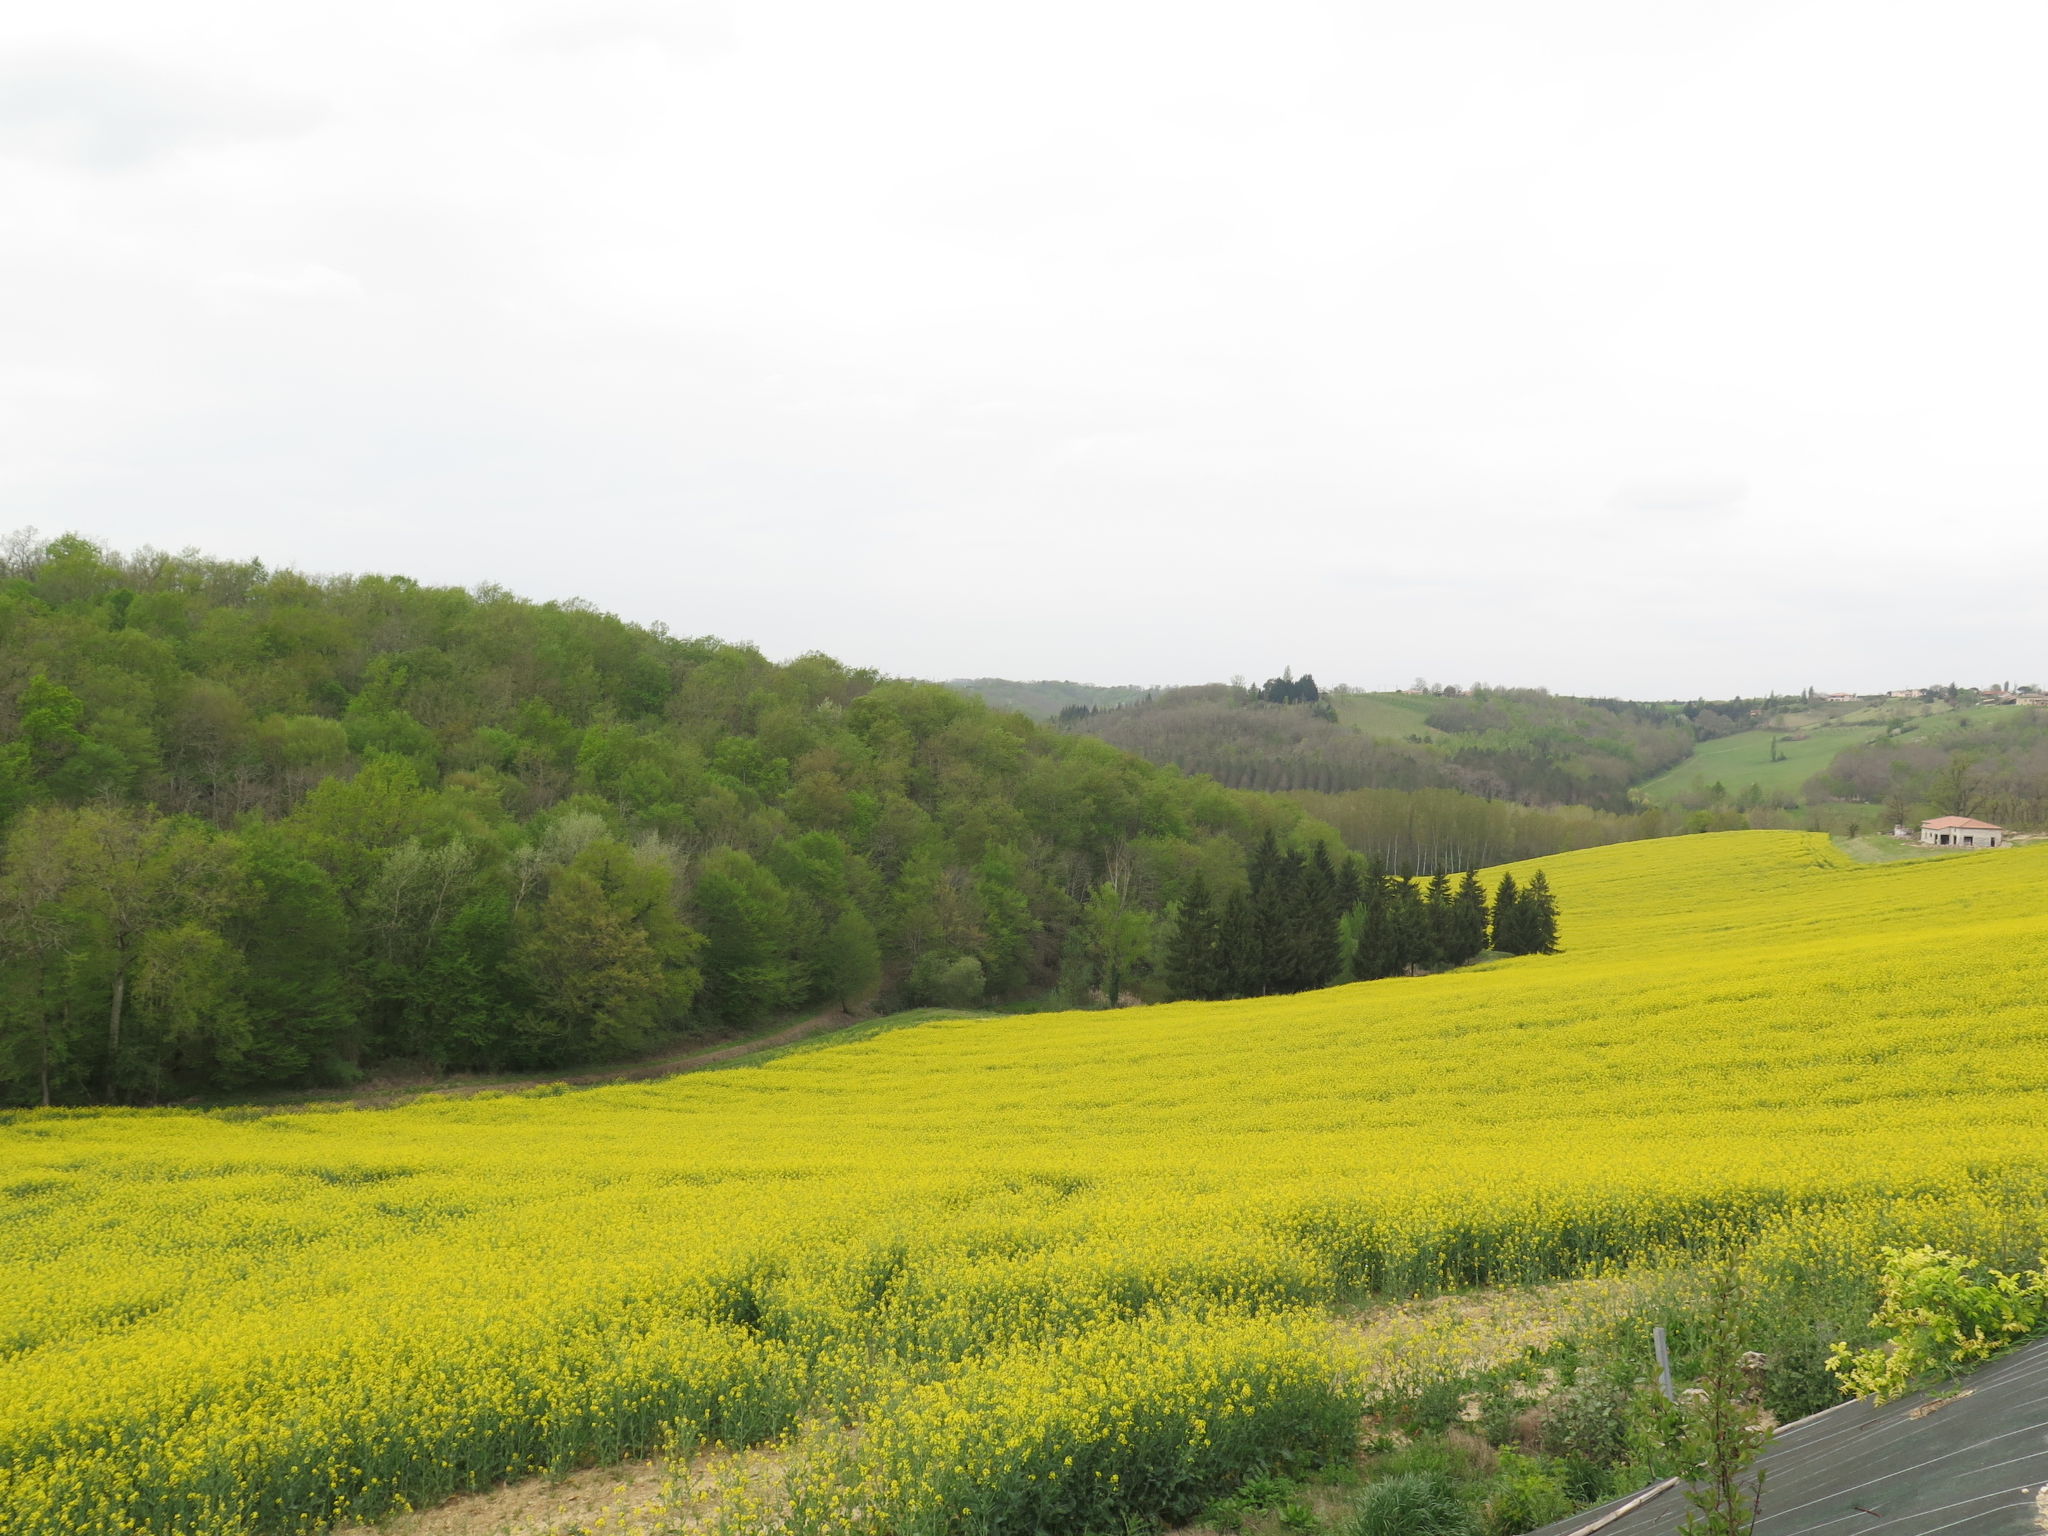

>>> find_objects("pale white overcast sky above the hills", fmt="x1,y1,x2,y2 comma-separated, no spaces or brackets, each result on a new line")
0,0,2048,694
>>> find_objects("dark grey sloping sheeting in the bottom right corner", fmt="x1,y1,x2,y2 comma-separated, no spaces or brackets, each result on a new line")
1534,1341,2048,1536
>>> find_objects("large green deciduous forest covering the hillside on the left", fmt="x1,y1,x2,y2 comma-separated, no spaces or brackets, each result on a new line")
0,537,1335,1102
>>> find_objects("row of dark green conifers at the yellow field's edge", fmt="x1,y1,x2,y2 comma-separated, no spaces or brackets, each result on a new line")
1165,838,1559,999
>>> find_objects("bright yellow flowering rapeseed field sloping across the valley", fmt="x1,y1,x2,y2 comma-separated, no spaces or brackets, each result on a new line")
0,831,2048,1536
